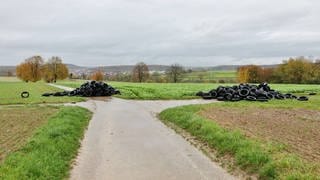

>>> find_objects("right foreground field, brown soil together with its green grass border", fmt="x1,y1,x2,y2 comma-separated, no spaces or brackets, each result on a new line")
160,95,320,179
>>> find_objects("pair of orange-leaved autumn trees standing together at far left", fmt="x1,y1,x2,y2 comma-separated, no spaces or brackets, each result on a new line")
16,56,69,83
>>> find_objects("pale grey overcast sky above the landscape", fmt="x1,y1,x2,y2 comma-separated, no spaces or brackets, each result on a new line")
0,0,320,66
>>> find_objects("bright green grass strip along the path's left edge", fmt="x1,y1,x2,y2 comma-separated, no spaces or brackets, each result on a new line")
0,107,91,179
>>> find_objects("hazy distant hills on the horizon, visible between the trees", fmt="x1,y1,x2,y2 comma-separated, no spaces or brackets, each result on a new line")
0,64,278,76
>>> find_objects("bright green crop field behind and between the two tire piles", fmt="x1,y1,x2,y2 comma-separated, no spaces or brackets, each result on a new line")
58,81,320,100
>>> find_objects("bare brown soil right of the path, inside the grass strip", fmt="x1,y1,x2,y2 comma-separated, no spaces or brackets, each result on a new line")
200,107,320,162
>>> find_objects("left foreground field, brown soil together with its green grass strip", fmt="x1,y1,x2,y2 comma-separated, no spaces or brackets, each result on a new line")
0,106,91,179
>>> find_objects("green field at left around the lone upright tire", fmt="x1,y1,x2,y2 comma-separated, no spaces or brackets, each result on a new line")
0,78,84,105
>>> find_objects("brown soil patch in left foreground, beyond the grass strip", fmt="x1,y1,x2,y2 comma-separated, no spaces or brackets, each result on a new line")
0,106,59,162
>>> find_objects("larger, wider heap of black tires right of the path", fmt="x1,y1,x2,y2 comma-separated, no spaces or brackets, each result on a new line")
196,83,308,102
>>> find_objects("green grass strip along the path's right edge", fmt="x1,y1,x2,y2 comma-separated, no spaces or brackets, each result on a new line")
160,105,275,178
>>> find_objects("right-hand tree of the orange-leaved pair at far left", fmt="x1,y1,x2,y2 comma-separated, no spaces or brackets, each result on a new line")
42,56,69,83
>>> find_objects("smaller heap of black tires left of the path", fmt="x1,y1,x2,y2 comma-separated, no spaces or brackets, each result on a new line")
42,81,120,97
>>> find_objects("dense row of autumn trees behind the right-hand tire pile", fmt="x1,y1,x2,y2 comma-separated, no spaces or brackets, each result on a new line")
237,57,320,84
